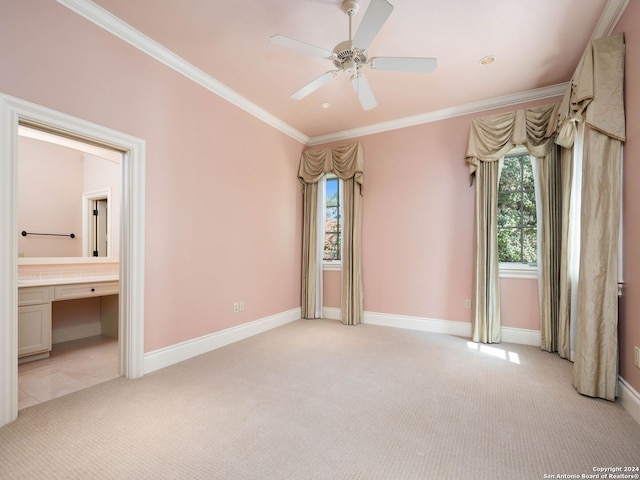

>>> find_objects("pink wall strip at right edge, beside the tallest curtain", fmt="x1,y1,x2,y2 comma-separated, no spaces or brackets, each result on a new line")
616,2,640,392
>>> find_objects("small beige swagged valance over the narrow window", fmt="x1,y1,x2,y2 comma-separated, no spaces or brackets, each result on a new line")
298,143,364,188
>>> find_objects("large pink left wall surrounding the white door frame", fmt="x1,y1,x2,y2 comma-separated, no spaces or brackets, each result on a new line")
0,0,302,352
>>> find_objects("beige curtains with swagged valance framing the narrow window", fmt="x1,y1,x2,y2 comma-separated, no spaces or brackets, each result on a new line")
298,143,364,325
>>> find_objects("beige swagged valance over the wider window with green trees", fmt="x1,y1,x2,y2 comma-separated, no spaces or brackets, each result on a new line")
465,103,559,175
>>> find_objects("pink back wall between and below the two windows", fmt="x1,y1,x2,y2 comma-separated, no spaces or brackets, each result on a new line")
324,99,558,330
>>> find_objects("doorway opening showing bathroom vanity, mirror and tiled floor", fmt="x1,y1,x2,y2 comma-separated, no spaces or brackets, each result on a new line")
16,131,122,411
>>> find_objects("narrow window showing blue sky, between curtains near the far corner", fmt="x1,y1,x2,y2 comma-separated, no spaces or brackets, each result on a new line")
322,175,342,264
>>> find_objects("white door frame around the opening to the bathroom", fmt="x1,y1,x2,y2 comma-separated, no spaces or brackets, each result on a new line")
0,93,146,427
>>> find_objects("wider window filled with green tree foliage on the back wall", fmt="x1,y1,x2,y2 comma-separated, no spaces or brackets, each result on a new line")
497,149,538,266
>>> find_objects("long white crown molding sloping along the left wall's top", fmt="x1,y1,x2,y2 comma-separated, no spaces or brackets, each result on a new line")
57,0,309,144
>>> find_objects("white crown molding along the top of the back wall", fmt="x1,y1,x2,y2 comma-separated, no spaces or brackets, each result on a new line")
308,83,568,146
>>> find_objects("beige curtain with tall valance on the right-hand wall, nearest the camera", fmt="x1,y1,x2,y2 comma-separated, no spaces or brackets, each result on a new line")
558,33,625,400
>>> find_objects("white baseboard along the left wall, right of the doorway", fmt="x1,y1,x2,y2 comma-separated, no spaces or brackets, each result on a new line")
144,308,301,375
